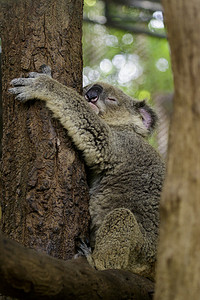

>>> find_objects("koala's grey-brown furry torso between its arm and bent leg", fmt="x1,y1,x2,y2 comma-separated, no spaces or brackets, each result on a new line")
90,129,165,243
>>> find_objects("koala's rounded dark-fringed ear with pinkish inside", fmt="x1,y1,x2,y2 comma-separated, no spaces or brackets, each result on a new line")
138,100,158,134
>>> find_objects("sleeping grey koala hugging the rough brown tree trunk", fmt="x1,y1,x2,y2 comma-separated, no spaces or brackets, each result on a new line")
9,65,165,279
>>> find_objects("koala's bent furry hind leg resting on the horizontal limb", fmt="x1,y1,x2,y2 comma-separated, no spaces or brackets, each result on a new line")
88,208,144,272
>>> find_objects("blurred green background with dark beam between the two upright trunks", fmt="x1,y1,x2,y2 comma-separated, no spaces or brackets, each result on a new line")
83,0,173,157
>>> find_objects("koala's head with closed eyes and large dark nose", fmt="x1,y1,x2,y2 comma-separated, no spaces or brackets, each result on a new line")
83,82,157,136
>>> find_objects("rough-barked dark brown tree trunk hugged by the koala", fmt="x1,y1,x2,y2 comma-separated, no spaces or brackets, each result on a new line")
0,0,89,259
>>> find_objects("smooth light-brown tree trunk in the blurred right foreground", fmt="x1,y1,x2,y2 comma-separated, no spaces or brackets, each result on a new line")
155,0,200,300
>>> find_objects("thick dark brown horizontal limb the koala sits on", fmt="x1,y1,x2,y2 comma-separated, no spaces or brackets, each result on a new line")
0,235,154,300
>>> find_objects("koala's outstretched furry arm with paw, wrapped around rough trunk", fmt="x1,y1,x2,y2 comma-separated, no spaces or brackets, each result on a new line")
9,73,110,169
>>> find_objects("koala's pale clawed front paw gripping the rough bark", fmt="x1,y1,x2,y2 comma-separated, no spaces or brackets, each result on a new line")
8,65,51,102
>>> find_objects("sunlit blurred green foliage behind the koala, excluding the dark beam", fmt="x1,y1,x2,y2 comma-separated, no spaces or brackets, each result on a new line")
83,0,173,99
